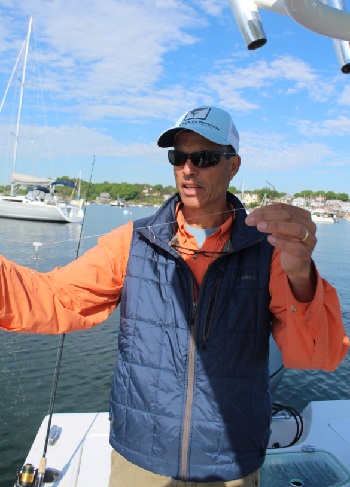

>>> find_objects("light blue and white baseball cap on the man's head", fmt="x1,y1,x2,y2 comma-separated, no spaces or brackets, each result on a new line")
158,106,239,154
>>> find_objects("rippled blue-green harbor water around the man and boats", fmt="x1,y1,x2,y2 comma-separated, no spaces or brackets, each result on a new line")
0,205,350,487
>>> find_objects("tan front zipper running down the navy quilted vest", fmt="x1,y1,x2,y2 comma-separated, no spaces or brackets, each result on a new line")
180,301,198,482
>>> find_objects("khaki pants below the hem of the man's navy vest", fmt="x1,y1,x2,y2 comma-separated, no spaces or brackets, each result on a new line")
108,450,259,487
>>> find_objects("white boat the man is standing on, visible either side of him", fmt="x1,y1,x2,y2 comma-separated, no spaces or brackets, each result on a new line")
18,400,350,487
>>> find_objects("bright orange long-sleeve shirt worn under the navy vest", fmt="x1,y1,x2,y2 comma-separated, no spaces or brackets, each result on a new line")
0,211,349,371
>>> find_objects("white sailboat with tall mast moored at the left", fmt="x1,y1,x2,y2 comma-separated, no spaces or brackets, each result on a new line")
0,18,84,223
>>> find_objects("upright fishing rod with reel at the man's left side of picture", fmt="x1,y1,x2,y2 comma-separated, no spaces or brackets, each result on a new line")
14,156,95,487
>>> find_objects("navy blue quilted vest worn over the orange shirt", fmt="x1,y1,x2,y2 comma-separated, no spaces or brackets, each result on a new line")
110,193,273,482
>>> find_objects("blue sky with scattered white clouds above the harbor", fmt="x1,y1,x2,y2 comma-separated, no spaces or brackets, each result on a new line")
0,0,350,194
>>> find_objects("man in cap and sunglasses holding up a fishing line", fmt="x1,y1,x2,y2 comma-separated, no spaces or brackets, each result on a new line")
0,107,347,487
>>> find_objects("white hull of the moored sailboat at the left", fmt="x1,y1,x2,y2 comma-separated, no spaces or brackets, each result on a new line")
0,197,84,223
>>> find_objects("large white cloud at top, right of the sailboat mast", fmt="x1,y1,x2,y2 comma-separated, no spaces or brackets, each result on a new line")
1,0,204,103
